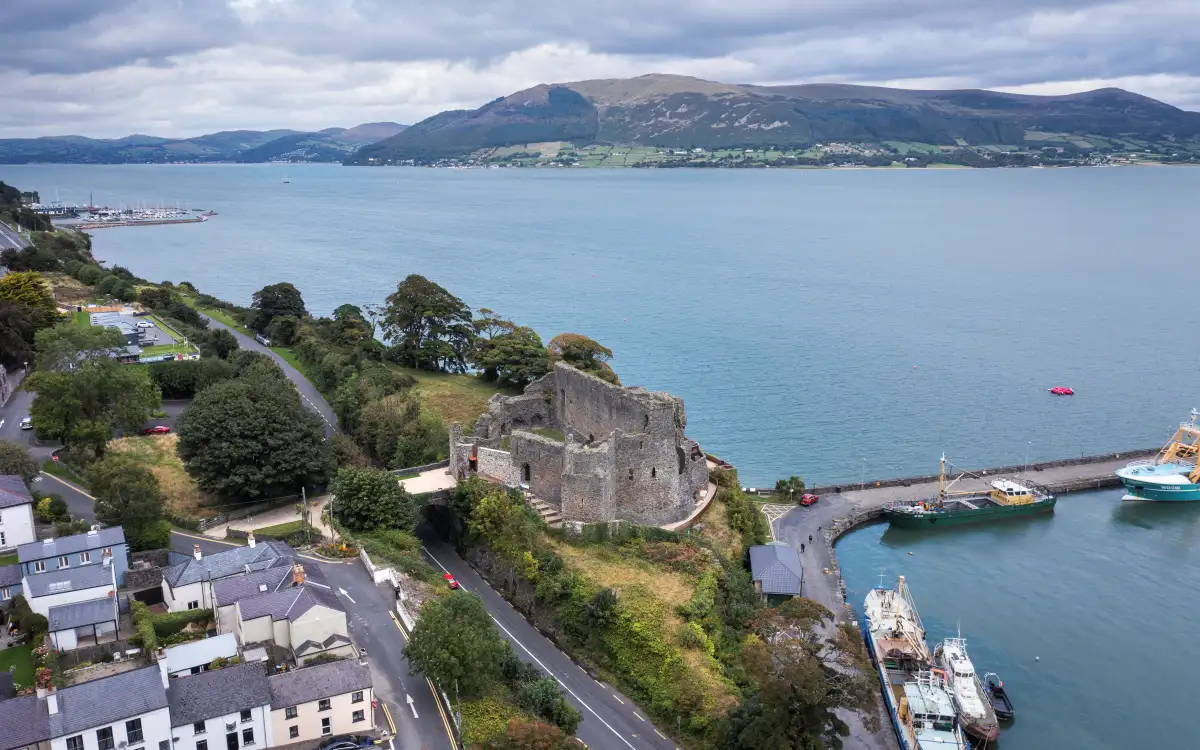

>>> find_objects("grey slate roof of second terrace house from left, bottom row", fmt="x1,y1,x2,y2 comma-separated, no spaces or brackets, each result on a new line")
43,666,167,737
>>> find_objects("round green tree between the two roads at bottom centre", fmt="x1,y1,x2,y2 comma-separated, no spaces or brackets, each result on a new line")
404,589,505,701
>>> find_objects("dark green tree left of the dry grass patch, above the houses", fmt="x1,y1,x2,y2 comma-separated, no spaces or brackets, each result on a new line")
88,454,170,552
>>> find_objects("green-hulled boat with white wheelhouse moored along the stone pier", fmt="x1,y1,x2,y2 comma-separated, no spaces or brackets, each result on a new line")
883,454,1057,528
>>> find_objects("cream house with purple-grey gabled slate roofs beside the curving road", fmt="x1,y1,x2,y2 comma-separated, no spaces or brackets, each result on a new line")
212,562,354,665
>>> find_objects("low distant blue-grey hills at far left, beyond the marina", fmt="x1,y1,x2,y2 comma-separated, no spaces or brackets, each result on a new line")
0,122,404,164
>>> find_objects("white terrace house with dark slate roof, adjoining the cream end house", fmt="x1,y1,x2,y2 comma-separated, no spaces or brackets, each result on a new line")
168,661,275,750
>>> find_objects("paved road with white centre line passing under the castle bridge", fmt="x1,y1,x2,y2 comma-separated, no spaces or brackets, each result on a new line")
421,530,677,750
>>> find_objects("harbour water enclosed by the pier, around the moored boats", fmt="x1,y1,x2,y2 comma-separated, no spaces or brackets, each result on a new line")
838,490,1200,750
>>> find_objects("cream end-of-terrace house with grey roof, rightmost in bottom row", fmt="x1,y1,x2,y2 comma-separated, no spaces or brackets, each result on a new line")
266,659,374,745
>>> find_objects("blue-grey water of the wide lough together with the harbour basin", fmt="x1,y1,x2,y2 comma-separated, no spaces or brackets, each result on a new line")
9,166,1200,750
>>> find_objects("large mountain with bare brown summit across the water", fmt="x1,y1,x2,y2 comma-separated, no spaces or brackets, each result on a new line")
346,74,1200,164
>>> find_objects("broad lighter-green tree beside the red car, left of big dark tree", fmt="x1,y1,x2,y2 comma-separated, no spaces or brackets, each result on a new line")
26,359,162,456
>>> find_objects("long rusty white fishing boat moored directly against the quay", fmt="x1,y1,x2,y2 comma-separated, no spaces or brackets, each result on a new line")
863,576,966,750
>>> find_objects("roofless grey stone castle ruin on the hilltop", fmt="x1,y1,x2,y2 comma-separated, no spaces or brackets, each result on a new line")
450,362,708,526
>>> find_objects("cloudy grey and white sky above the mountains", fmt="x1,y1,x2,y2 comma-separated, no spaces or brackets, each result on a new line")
0,0,1200,138
